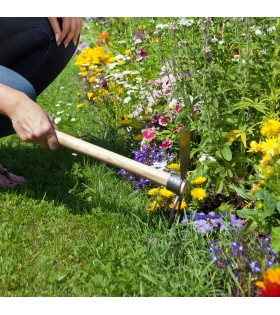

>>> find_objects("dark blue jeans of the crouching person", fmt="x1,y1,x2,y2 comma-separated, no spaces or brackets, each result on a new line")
0,17,76,137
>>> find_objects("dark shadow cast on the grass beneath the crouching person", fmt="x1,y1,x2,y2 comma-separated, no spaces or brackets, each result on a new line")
0,137,149,219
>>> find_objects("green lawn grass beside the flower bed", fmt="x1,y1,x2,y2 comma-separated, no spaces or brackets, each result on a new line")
0,62,231,297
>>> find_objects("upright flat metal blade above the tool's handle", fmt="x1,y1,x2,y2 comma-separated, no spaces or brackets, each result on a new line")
179,127,191,179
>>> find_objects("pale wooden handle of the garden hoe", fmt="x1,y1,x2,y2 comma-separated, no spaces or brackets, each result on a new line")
56,130,183,194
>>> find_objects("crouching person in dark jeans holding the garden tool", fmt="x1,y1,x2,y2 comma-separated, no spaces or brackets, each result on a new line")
0,17,83,188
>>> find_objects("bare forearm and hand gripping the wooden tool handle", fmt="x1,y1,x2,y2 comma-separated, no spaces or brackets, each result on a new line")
0,83,59,150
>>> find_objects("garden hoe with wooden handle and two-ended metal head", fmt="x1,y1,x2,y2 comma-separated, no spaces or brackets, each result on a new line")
56,128,190,228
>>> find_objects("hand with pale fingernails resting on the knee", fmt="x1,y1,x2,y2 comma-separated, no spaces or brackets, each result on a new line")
48,17,83,48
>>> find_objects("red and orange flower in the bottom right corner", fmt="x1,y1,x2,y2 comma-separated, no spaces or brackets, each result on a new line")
256,267,280,297
